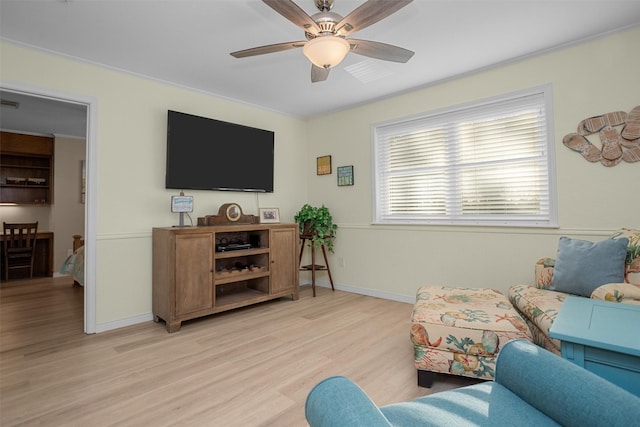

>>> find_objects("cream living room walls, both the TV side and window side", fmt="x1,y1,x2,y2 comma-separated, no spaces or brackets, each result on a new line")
0,29,640,332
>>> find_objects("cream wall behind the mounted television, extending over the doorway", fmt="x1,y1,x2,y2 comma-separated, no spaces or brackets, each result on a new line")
0,41,307,330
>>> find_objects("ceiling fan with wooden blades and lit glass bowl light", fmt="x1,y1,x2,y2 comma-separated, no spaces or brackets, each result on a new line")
231,0,413,83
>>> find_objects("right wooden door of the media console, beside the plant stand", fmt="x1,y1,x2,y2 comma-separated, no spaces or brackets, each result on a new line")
270,227,298,299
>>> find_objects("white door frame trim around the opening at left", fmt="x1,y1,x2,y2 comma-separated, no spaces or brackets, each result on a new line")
0,83,97,334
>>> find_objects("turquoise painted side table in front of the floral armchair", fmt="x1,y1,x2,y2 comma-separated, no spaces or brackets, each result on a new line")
549,297,640,396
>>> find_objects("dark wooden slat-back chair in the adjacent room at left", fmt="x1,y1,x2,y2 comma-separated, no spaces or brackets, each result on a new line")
2,222,38,281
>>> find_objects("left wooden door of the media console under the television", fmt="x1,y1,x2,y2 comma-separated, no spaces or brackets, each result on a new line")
175,233,213,317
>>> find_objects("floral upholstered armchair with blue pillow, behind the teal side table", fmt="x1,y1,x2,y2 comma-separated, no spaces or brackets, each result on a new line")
509,228,640,354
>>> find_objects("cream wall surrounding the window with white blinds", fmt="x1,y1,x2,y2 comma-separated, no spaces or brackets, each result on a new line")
307,28,640,301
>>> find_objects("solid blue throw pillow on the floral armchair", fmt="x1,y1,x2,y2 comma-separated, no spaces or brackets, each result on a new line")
549,236,629,297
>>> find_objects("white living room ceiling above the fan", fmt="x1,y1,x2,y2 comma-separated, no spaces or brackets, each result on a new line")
0,0,640,136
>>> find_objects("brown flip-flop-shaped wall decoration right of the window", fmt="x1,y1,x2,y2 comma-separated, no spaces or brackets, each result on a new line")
562,105,640,167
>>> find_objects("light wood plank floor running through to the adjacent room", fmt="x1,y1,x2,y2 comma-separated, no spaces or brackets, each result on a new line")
0,278,476,427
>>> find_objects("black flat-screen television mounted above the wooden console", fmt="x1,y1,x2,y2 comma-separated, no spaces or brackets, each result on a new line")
165,110,274,193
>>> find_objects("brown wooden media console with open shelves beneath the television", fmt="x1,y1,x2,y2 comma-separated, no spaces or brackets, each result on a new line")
153,224,299,332
